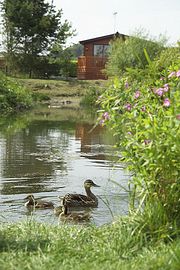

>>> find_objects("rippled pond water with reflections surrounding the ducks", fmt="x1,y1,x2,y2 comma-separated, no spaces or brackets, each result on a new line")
0,107,129,226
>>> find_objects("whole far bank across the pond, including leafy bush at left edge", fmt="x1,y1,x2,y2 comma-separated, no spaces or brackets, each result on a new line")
0,73,106,114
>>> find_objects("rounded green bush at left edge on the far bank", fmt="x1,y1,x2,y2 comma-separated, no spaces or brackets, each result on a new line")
0,70,33,113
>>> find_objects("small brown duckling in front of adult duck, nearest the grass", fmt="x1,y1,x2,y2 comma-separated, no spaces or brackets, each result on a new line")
59,200,90,221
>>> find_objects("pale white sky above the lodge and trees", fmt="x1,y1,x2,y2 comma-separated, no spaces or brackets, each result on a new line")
51,0,180,45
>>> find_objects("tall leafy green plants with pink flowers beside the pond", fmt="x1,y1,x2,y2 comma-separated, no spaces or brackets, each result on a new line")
100,52,180,238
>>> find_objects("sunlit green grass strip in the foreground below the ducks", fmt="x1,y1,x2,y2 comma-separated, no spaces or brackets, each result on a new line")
0,218,180,270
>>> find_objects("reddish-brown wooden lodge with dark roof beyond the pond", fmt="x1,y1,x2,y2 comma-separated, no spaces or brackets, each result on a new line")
77,32,127,80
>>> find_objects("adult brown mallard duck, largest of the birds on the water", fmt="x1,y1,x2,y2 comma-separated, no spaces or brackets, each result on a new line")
63,179,100,208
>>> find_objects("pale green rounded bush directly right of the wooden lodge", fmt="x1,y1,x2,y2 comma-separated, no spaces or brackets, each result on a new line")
106,33,165,76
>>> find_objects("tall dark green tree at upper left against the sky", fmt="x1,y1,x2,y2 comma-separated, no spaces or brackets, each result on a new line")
1,0,73,77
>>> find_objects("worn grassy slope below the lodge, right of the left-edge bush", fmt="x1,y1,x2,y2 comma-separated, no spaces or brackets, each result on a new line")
18,79,106,106
